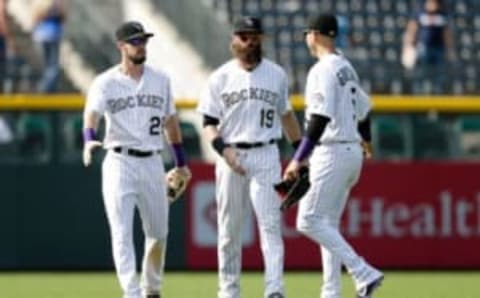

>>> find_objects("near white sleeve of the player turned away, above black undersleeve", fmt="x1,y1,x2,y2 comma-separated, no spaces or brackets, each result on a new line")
307,67,336,119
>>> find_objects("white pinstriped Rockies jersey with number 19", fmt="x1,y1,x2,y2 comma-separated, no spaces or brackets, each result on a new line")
197,58,291,143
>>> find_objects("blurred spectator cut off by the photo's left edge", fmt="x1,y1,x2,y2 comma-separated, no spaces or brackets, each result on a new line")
0,0,16,92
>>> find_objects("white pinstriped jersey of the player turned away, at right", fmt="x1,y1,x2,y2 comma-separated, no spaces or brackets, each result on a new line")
305,54,371,144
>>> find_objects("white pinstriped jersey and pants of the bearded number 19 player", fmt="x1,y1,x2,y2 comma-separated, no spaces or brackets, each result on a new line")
198,59,291,298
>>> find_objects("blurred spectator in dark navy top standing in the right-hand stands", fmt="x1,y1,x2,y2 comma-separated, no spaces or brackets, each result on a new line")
402,0,456,94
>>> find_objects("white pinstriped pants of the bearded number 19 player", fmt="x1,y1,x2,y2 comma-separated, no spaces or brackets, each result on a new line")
215,144,284,298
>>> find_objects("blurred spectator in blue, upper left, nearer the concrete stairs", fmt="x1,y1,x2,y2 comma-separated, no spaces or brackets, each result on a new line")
32,0,66,93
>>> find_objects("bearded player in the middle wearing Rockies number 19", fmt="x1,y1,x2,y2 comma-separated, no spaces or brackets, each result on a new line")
198,17,301,298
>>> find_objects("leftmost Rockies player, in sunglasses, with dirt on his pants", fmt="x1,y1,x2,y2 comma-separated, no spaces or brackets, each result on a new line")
83,22,189,298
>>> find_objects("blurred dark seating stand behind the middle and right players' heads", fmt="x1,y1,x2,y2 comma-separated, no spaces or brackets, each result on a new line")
209,0,480,94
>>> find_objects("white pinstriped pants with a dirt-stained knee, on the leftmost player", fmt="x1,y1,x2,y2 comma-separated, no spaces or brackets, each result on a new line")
102,151,168,298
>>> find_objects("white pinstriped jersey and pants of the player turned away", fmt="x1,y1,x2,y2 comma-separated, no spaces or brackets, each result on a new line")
297,51,381,298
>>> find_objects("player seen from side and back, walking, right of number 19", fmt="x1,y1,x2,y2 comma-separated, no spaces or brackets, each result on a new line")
284,15,383,298
